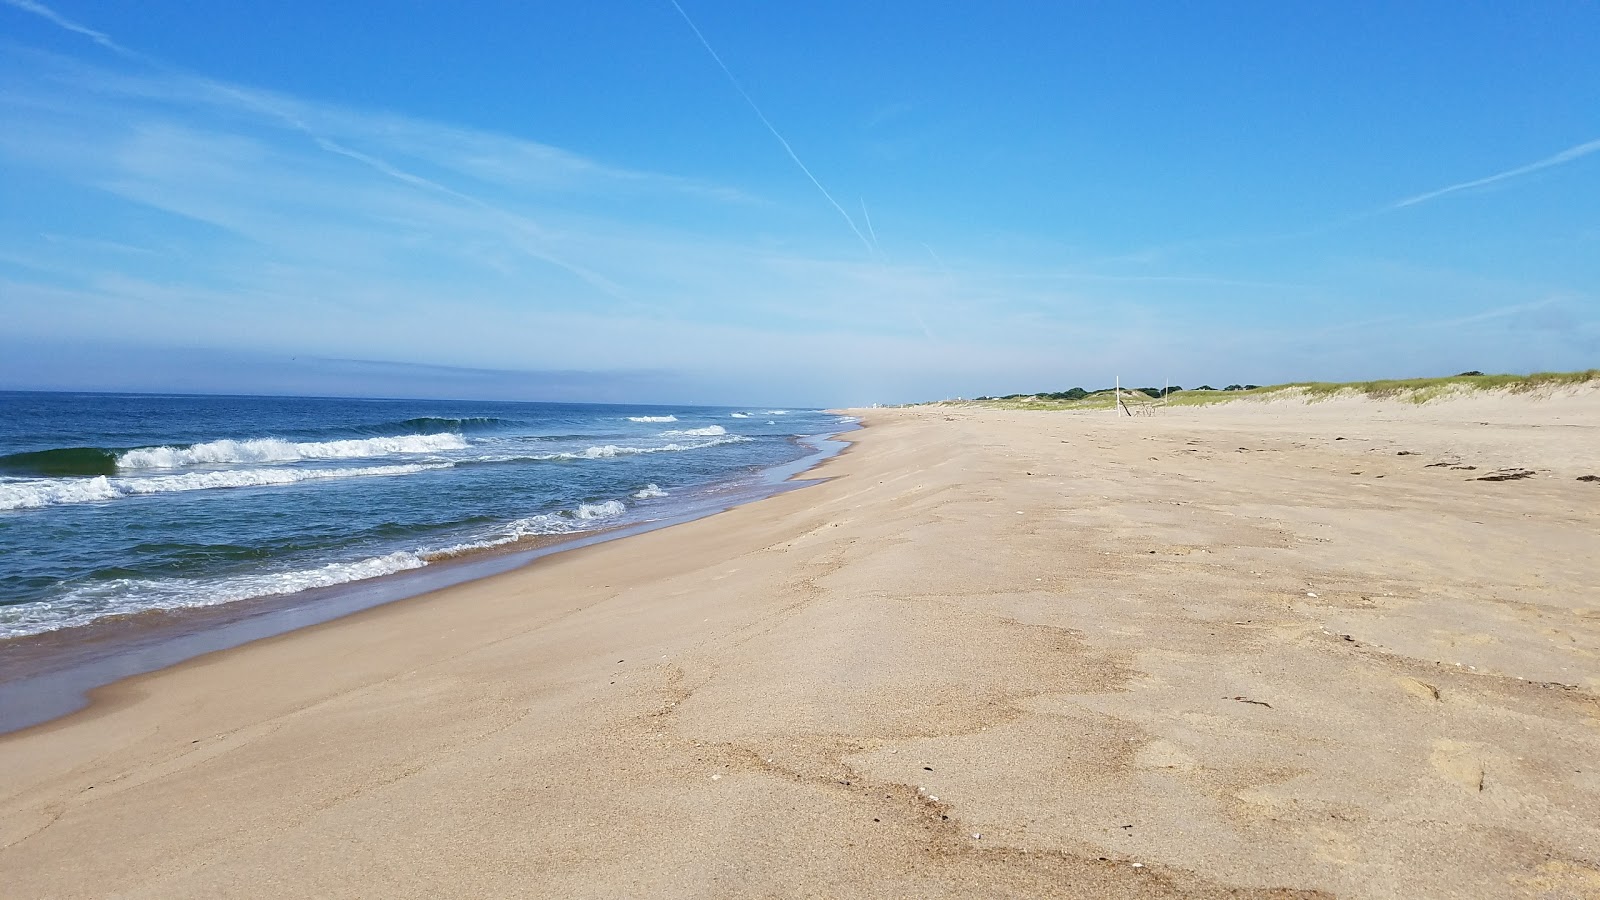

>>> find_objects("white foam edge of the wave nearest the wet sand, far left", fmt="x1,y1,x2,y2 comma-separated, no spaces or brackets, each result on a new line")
0,551,427,637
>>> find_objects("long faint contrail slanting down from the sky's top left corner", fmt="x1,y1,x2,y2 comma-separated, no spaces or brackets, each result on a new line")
0,0,629,299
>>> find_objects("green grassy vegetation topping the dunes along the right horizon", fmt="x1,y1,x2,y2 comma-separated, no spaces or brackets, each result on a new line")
940,368,1600,410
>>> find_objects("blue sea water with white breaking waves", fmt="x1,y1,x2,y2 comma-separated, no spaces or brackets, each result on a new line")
0,392,848,637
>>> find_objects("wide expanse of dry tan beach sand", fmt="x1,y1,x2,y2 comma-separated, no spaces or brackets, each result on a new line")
0,391,1600,898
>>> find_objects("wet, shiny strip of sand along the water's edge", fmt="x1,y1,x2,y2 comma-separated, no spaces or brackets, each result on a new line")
0,420,864,738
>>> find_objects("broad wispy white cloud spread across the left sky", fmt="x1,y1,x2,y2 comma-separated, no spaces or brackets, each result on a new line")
0,58,1017,357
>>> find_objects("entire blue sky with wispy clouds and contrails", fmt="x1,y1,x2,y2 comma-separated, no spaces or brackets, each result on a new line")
0,0,1600,405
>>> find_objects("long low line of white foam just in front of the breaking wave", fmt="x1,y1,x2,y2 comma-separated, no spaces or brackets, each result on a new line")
0,463,451,509
